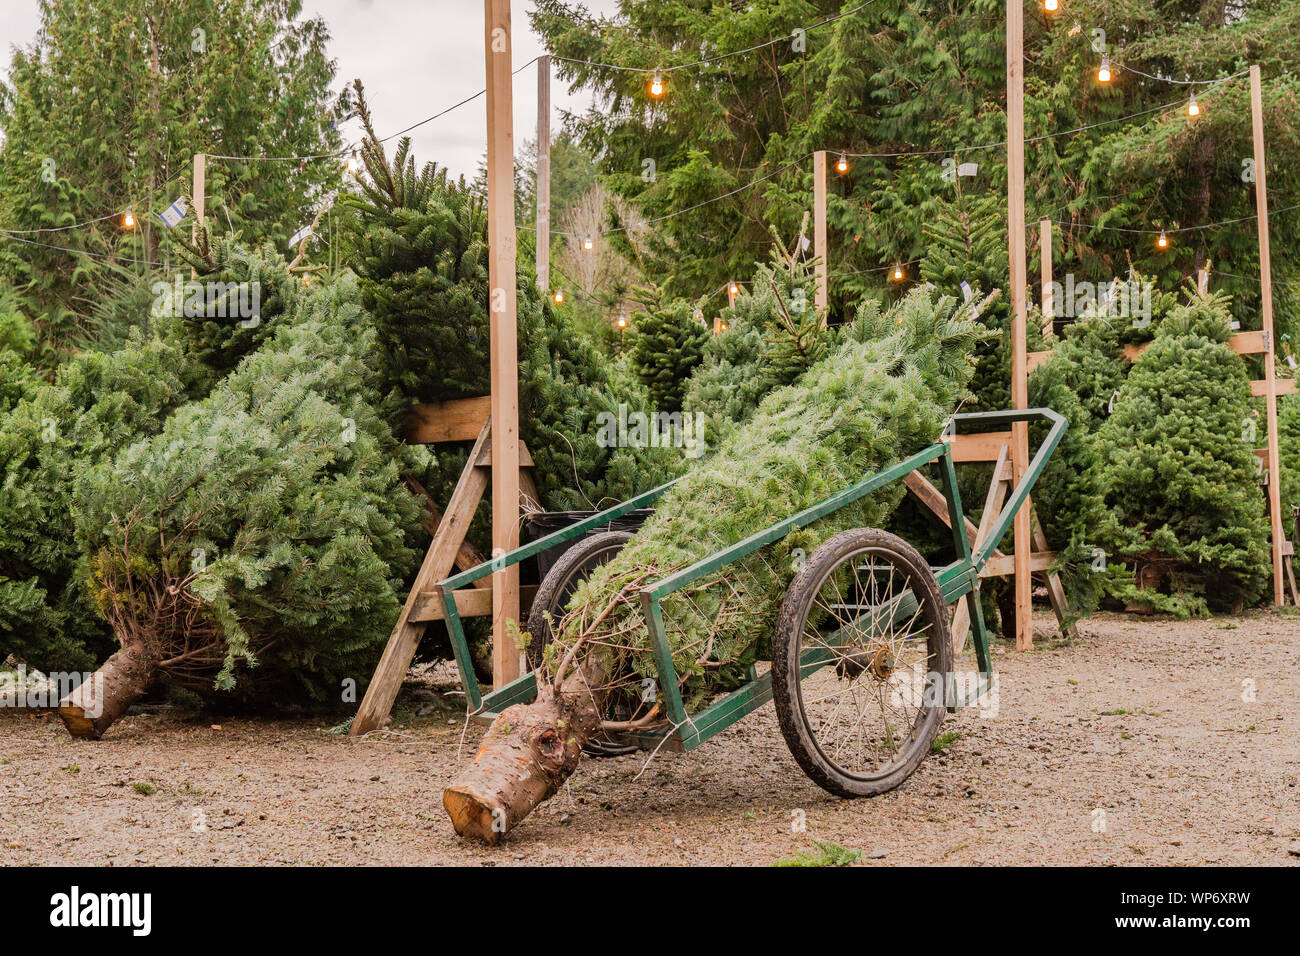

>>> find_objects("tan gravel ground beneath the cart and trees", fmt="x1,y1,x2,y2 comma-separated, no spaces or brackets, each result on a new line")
0,613,1300,866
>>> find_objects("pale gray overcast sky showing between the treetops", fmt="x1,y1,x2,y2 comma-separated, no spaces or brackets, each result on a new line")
0,0,618,177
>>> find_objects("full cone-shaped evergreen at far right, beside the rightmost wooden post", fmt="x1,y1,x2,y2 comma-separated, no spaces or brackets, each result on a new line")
1097,295,1269,614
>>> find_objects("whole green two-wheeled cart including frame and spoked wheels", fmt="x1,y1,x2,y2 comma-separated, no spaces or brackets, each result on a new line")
437,408,1066,796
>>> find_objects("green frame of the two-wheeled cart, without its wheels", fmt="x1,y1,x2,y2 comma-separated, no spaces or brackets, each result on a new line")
436,408,1066,780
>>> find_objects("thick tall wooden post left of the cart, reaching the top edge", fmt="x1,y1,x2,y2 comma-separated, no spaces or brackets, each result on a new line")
484,0,519,687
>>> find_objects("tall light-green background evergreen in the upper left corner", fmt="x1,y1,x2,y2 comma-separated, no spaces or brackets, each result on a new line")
0,0,348,346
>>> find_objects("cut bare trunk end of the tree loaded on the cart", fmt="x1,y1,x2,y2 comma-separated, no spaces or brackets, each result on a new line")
442,656,606,844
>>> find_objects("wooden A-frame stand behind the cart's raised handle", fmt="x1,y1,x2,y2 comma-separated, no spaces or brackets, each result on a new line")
904,432,1074,654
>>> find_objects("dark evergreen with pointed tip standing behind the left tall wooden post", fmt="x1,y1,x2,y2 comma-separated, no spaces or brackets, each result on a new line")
342,83,684,515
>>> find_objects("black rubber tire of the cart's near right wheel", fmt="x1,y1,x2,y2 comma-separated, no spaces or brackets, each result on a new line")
772,528,952,797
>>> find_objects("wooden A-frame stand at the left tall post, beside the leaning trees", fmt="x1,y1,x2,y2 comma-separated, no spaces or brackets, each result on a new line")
348,408,541,737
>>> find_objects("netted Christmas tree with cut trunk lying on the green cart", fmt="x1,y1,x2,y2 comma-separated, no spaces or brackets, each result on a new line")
443,286,988,842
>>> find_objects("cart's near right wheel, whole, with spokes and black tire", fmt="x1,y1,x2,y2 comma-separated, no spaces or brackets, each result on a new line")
772,528,952,797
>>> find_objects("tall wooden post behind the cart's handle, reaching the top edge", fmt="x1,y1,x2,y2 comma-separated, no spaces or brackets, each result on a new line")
1006,0,1034,650
